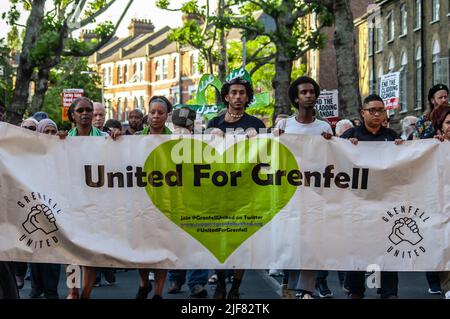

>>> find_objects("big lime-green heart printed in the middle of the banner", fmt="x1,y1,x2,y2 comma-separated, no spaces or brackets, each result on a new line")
144,138,298,263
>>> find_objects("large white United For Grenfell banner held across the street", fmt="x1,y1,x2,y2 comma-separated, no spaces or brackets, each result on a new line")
0,123,450,271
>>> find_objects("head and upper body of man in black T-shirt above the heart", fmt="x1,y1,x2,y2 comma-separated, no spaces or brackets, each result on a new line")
207,78,265,133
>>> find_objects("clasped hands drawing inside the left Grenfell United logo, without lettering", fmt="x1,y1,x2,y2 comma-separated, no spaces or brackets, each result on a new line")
22,204,58,235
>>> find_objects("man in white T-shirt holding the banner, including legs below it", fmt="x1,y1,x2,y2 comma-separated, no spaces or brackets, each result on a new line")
274,76,333,299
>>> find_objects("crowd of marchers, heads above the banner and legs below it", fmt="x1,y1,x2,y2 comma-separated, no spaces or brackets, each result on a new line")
0,76,450,299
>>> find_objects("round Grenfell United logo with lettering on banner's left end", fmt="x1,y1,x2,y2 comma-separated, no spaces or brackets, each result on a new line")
17,192,61,249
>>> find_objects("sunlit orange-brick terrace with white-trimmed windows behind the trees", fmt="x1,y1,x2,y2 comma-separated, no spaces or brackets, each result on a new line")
88,19,200,121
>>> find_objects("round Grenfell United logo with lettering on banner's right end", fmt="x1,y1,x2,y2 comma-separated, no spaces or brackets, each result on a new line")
381,205,430,259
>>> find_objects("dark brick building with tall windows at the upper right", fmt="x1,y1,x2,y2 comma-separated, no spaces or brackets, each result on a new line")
356,0,450,124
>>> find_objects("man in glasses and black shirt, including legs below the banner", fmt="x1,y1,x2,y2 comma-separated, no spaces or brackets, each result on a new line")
341,94,402,299
